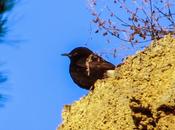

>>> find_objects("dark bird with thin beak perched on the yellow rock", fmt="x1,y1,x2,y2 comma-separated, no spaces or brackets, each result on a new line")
62,47,115,90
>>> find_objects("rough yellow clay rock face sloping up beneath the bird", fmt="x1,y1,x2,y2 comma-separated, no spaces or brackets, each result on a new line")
57,35,175,130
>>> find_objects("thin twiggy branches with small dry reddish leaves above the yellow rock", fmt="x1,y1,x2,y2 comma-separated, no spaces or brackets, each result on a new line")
88,0,175,44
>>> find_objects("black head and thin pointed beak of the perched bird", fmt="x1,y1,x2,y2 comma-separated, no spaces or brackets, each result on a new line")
62,47,93,61
